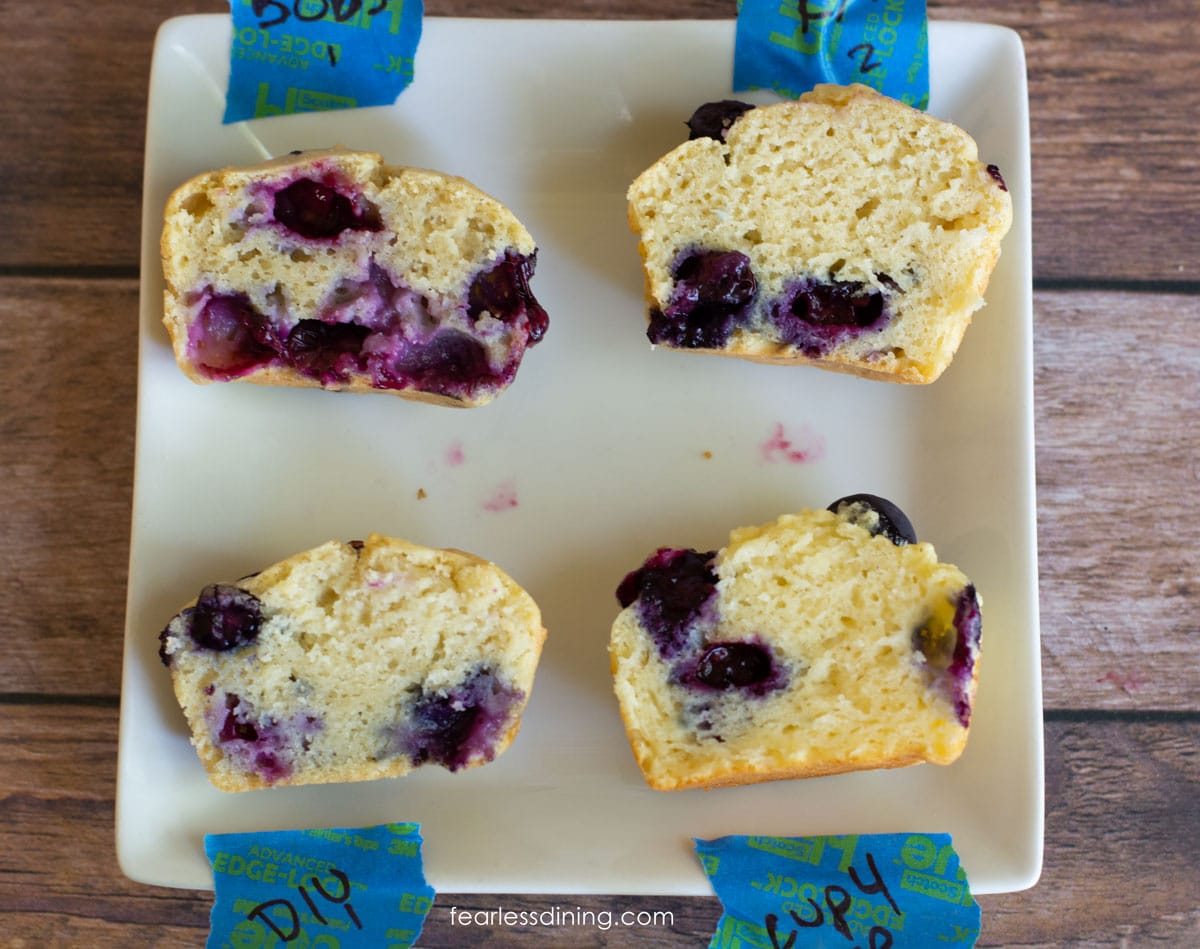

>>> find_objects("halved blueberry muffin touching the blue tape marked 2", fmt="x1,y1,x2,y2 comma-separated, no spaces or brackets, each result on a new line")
628,85,1013,383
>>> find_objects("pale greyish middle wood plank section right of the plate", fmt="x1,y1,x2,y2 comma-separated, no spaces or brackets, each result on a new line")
1034,292,1200,710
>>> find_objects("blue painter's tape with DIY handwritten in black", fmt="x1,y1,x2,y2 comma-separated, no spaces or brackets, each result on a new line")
204,823,436,949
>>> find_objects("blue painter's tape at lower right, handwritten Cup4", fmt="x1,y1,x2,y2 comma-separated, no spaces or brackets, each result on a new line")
695,834,980,949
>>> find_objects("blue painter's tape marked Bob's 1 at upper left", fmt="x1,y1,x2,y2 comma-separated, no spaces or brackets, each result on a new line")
223,0,424,122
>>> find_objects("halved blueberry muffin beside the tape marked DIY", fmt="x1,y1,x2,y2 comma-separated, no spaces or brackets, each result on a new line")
160,534,546,791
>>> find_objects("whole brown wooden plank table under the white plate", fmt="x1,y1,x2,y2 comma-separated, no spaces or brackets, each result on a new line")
0,0,1200,947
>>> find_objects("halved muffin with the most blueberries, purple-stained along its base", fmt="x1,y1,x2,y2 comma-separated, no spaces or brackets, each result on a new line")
162,148,548,407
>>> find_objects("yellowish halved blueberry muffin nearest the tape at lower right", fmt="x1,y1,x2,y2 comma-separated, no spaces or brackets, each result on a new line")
610,494,980,791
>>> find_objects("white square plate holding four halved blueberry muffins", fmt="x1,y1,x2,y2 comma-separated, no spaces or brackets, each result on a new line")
116,16,1043,894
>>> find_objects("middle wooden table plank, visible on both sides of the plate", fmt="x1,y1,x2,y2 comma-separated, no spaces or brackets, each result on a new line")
0,278,1200,710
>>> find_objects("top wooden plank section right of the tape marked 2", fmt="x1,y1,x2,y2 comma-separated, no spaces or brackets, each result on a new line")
929,0,1200,283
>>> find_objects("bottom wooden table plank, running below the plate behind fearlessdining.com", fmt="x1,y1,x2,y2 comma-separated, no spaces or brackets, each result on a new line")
0,704,1200,949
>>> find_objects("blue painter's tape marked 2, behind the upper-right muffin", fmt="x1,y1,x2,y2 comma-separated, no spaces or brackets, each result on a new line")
733,0,929,109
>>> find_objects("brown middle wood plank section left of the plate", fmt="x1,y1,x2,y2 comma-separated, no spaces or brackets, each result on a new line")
0,278,138,696
